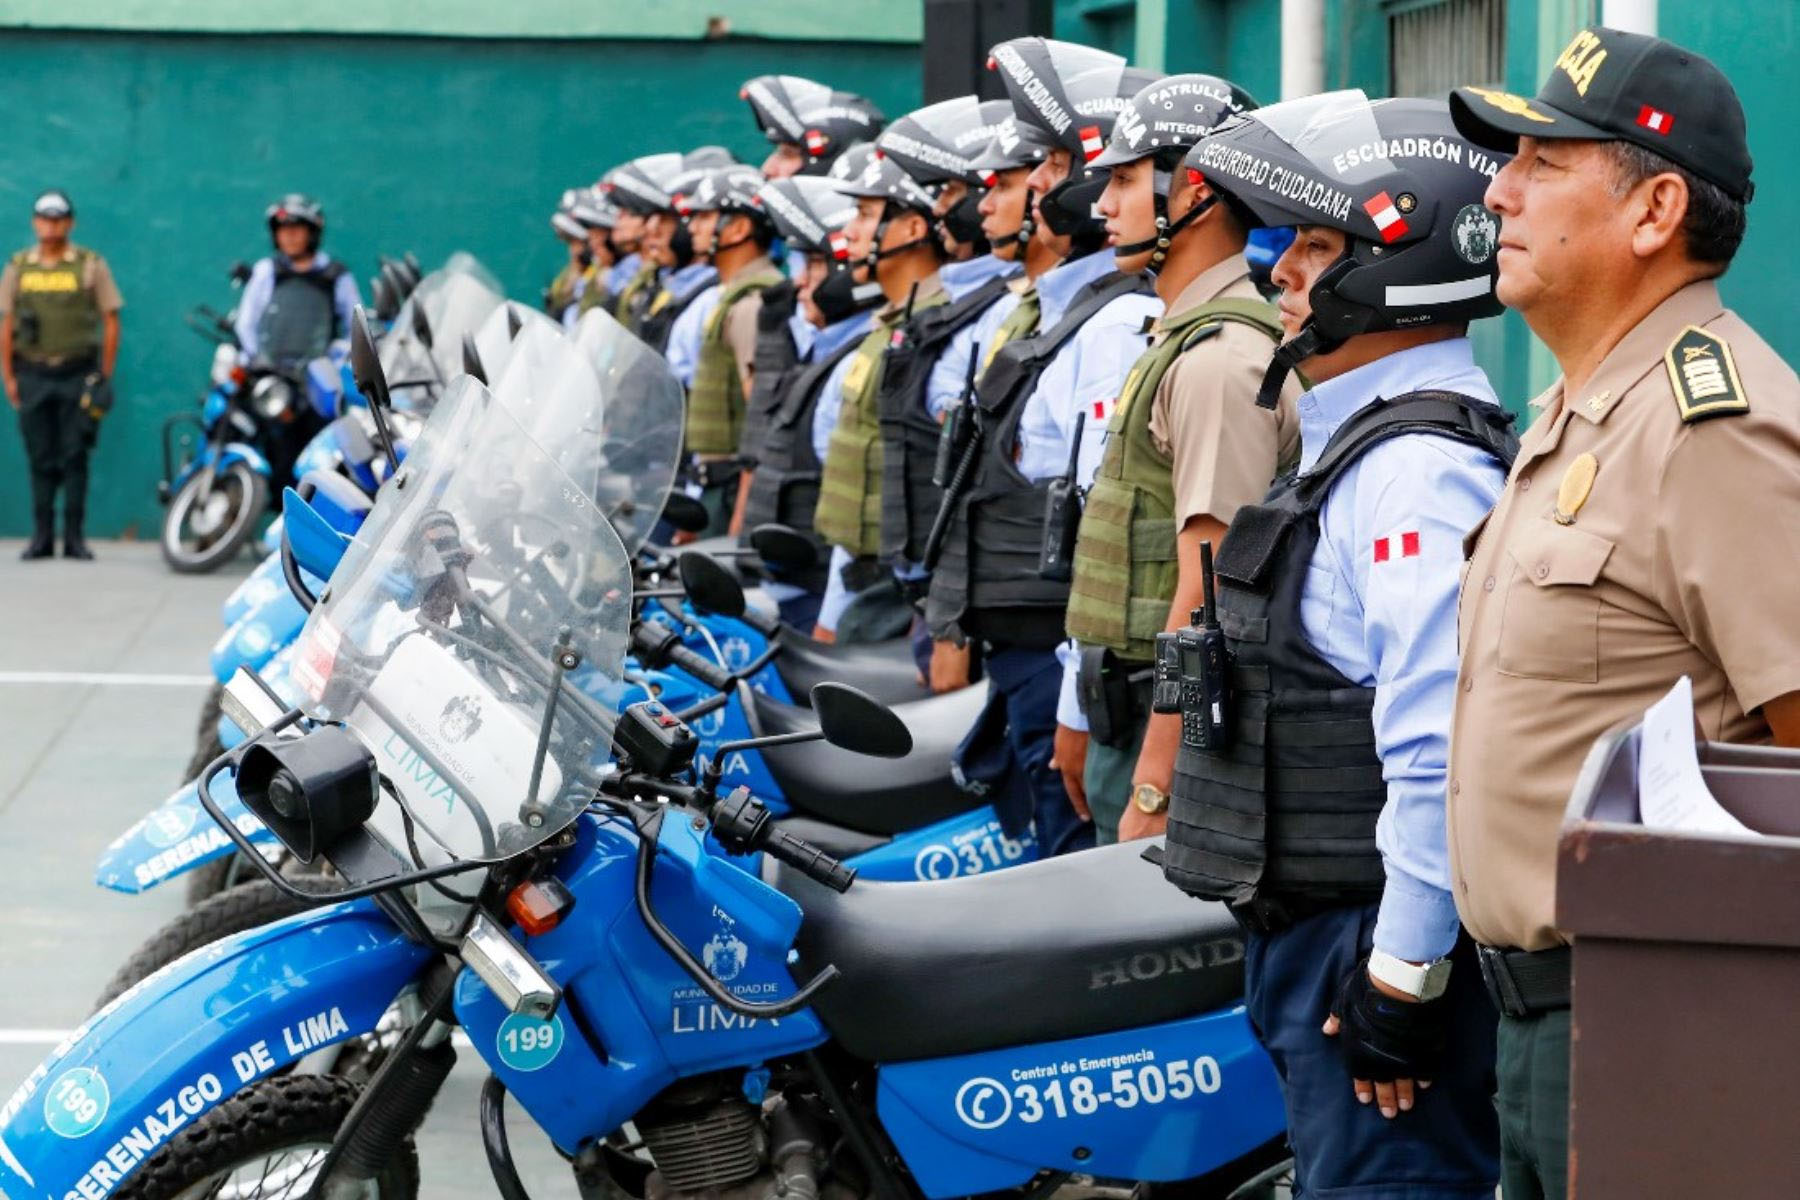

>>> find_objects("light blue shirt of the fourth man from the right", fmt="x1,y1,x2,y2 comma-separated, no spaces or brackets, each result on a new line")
1008,250,1163,486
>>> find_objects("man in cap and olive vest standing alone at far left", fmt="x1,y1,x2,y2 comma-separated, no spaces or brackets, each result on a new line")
0,189,124,560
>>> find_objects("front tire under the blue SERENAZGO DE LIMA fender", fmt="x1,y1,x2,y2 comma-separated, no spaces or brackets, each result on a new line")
117,1076,419,1200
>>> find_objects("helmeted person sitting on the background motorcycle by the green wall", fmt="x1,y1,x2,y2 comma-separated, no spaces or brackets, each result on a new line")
232,193,362,365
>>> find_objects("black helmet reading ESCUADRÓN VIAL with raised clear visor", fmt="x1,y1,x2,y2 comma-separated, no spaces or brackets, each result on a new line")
1184,90,1505,408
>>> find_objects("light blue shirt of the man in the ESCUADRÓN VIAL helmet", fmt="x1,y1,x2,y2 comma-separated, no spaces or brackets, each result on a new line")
1300,338,1507,963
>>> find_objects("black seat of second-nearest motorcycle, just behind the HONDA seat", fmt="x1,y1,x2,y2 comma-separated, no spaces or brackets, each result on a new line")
745,684,988,837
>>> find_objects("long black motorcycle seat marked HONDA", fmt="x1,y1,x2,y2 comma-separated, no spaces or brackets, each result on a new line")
769,842,1244,1063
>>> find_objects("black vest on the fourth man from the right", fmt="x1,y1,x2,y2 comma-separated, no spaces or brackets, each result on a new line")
925,272,1150,649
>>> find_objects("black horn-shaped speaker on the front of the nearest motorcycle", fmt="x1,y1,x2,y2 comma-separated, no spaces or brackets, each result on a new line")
238,725,380,864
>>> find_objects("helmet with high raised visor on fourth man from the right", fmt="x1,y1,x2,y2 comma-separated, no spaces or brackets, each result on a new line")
988,38,1161,248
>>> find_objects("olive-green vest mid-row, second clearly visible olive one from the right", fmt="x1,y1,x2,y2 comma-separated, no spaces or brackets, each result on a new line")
812,291,950,558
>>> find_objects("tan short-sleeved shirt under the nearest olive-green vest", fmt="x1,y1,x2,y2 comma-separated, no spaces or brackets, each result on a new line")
1150,254,1305,529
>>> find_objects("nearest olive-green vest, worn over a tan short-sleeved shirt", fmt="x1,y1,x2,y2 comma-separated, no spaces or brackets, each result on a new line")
1067,299,1282,662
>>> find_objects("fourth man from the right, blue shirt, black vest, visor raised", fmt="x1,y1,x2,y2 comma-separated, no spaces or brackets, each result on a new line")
925,38,1163,853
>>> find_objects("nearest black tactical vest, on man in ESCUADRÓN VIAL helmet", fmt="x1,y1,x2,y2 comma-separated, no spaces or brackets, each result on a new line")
1163,392,1519,910
